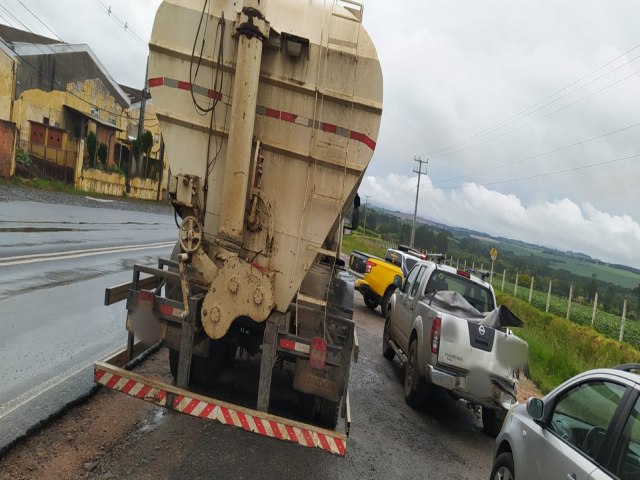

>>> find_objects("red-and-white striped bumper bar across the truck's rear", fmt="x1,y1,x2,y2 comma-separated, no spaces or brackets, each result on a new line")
94,346,351,456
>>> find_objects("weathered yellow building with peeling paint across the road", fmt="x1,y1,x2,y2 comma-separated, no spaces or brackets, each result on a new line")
0,25,167,199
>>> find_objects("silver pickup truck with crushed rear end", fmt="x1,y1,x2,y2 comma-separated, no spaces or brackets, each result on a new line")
382,261,528,436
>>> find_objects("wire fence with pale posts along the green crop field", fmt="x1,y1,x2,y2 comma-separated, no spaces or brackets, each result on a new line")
445,258,640,349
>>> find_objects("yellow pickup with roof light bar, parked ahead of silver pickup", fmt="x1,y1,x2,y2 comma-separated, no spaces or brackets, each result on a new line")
356,245,424,317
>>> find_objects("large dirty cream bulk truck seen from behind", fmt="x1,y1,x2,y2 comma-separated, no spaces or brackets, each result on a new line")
95,0,382,454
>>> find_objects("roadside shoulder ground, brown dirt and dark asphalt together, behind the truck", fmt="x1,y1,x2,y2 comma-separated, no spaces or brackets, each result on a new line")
0,293,495,480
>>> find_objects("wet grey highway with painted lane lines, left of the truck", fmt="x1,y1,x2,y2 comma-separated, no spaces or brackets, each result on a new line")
0,186,176,450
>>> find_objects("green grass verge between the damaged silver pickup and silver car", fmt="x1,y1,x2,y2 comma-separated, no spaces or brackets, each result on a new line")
498,293,640,393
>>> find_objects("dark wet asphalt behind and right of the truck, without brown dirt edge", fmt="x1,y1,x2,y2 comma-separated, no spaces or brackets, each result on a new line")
86,293,495,480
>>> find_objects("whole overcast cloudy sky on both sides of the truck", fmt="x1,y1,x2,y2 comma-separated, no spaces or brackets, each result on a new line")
5,0,640,268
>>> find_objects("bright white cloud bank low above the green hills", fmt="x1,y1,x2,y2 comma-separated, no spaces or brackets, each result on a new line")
360,174,640,266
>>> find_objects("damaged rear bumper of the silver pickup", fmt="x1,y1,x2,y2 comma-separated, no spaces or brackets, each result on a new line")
425,365,517,410
